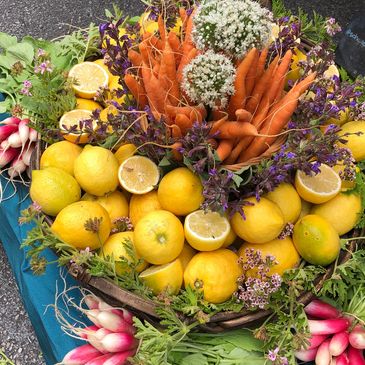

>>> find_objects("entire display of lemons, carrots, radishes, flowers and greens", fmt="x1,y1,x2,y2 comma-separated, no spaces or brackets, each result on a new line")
0,0,365,365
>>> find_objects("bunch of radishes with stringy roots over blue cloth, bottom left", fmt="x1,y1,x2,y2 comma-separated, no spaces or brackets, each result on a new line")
60,295,138,365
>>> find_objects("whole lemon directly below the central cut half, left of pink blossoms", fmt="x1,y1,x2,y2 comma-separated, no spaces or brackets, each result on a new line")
184,248,242,303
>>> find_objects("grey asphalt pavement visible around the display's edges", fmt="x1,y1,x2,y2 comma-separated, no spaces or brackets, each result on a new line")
0,0,365,365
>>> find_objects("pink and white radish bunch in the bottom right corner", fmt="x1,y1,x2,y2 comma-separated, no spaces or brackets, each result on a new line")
295,299,365,365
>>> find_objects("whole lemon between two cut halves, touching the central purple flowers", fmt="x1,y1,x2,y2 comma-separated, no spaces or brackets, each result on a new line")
157,167,204,215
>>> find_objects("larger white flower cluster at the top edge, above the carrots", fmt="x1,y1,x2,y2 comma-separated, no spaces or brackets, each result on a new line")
193,0,273,58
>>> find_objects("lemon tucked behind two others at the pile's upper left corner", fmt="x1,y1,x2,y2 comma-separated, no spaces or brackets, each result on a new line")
40,141,82,176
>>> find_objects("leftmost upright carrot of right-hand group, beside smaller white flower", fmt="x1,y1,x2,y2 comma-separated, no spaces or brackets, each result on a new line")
228,48,257,119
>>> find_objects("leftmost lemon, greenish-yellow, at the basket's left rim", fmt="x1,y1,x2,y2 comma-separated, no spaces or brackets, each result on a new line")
29,167,81,216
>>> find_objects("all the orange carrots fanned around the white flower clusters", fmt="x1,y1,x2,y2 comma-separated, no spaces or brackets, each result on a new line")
124,9,316,168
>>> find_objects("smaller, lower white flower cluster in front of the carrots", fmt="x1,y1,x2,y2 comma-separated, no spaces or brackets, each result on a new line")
182,50,236,107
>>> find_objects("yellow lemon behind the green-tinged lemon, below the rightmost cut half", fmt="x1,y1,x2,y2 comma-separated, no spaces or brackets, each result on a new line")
311,193,361,236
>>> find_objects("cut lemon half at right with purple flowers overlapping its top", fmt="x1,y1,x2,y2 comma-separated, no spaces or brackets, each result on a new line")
295,164,341,204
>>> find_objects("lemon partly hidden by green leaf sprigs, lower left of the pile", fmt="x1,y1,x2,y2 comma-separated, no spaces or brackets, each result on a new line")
99,232,148,275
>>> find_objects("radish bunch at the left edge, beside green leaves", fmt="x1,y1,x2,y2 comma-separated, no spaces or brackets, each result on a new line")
0,117,38,179
